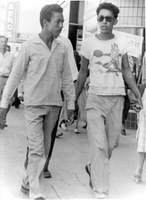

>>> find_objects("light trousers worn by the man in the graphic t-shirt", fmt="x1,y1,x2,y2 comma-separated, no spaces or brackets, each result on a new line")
86,94,124,195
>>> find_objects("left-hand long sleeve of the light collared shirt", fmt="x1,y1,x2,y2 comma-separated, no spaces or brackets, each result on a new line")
0,43,29,108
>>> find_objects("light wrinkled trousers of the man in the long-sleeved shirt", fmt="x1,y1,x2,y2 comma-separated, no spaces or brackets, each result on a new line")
22,105,61,198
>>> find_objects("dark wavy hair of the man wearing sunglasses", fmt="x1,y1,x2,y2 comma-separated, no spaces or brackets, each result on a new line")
96,2,120,18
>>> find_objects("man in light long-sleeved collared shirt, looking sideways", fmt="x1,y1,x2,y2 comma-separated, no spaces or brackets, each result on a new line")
0,4,75,200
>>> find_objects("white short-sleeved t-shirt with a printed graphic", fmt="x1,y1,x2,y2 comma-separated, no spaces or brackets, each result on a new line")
81,36,125,95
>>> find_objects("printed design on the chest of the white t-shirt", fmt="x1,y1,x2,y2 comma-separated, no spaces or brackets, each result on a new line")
93,43,122,73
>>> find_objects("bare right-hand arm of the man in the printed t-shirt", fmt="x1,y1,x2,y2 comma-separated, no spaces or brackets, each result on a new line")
122,54,142,107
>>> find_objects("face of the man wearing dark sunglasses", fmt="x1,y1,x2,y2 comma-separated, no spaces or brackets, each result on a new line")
97,9,117,33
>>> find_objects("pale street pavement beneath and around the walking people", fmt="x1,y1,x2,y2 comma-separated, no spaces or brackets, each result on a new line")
0,105,146,200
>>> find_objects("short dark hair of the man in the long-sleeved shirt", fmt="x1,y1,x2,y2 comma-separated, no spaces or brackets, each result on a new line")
40,4,63,27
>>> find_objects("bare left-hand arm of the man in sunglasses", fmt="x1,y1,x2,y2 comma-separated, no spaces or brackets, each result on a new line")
76,56,89,102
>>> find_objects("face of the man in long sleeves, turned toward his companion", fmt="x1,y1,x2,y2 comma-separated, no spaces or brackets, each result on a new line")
46,12,64,38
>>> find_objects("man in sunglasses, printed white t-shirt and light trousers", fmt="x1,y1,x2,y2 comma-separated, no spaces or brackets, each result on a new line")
76,3,142,198
